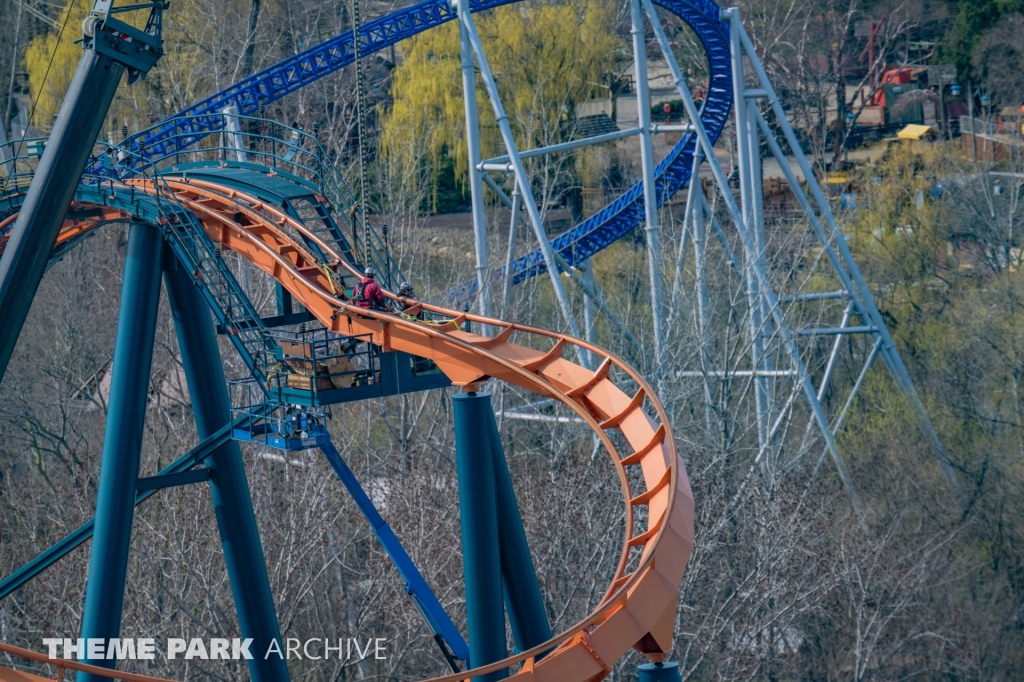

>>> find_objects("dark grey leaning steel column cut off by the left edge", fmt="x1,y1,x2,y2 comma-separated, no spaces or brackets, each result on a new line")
0,50,124,379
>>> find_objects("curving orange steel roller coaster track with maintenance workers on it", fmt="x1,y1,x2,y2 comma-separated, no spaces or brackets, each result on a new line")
0,177,694,682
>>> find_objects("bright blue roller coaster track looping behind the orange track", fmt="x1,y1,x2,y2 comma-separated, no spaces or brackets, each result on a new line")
96,0,732,300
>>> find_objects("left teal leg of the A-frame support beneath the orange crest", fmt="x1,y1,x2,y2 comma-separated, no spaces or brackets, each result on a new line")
78,223,164,682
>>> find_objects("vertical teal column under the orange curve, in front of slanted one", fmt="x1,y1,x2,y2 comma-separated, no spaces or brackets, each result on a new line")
452,393,508,682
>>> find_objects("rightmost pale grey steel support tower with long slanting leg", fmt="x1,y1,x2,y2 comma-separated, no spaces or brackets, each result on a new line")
639,0,967,507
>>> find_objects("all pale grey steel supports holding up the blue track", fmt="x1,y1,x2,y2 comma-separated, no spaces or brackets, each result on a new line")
454,0,967,509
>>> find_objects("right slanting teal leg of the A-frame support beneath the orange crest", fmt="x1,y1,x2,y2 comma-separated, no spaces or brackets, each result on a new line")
165,250,290,682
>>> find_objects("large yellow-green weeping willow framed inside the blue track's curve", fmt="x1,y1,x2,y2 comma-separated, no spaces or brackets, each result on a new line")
380,0,622,211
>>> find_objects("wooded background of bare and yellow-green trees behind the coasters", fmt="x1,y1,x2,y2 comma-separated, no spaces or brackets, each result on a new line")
0,0,1024,681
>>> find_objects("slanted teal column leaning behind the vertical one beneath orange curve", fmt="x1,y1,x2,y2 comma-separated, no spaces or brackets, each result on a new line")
483,411,551,651
